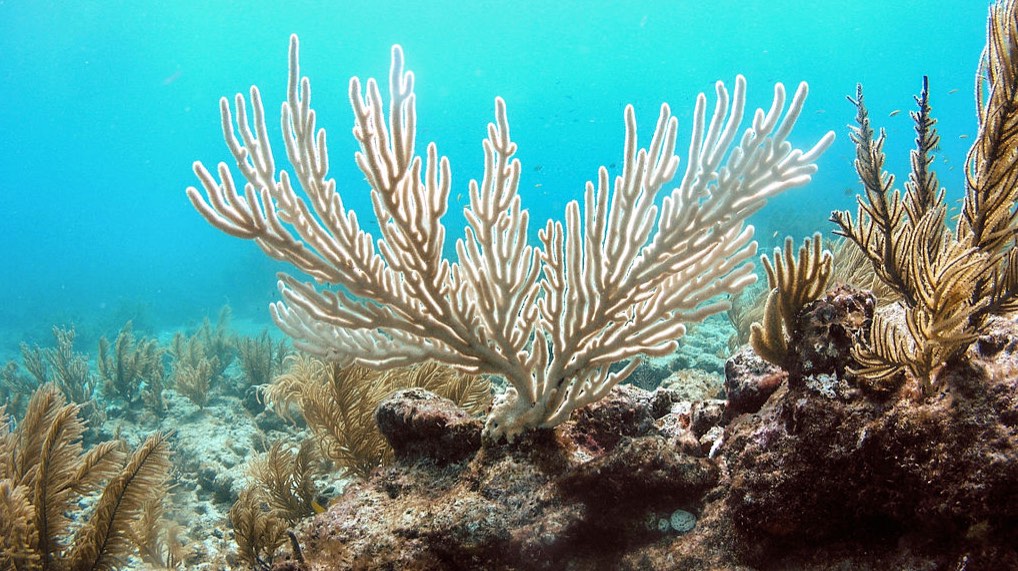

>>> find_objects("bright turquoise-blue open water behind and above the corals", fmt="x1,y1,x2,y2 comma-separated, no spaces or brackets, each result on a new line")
0,0,987,355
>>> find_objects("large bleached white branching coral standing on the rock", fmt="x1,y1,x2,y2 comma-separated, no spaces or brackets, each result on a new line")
187,37,834,439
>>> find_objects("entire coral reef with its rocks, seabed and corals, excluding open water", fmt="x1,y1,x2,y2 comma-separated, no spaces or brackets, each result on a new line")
0,0,1018,571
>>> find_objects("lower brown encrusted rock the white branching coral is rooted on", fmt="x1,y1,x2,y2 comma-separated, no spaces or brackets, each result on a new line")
289,386,720,570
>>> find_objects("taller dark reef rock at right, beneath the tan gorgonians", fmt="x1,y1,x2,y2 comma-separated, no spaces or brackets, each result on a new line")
723,311,1018,569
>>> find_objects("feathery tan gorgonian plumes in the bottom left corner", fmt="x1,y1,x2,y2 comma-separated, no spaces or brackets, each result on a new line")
0,385,170,571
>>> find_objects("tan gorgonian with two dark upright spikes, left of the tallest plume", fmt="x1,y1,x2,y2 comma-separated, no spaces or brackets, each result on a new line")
832,79,988,392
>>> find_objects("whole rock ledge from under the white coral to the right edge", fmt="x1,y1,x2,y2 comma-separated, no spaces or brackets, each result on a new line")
275,291,1018,570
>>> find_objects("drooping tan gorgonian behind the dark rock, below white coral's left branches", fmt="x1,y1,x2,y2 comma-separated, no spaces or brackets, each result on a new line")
263,353,491,477
